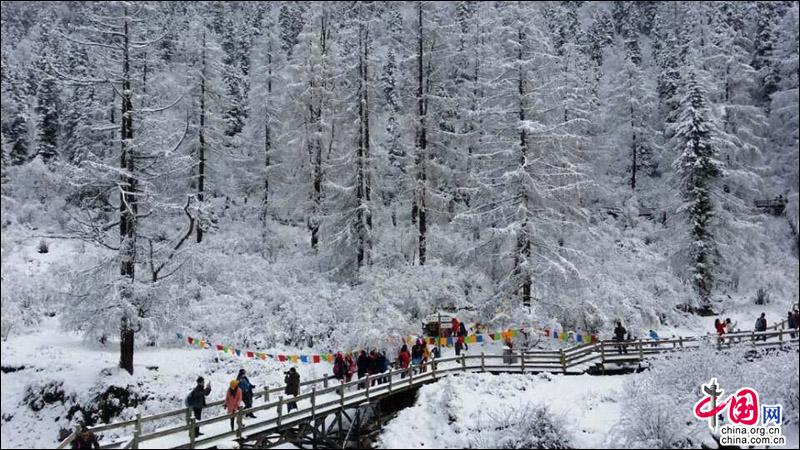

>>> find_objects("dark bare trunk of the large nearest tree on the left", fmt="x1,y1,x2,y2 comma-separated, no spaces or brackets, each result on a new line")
119,8,138,374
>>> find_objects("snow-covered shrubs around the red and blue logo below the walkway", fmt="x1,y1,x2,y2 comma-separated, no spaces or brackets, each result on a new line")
607,345,800,448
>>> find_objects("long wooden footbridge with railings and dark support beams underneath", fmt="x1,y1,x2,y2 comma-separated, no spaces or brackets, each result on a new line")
58,322,800,448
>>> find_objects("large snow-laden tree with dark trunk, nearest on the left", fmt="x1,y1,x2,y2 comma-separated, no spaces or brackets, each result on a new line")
59,3,194,373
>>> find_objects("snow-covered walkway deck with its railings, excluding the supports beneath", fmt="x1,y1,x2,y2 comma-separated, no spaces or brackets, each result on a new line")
58,328,799,448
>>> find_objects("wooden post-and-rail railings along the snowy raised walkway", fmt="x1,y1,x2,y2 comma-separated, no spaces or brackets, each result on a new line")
57,322,800,448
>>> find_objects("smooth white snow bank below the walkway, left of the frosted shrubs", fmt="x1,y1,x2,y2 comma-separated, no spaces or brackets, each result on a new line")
379,373,626,448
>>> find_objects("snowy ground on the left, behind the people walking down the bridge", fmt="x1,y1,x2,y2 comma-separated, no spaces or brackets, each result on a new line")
2,319,338,448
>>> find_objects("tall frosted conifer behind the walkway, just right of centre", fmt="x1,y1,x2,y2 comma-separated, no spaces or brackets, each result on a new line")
460,2,580,306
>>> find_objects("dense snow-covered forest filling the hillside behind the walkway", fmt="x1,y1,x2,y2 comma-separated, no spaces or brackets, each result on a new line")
1,1,800,446
